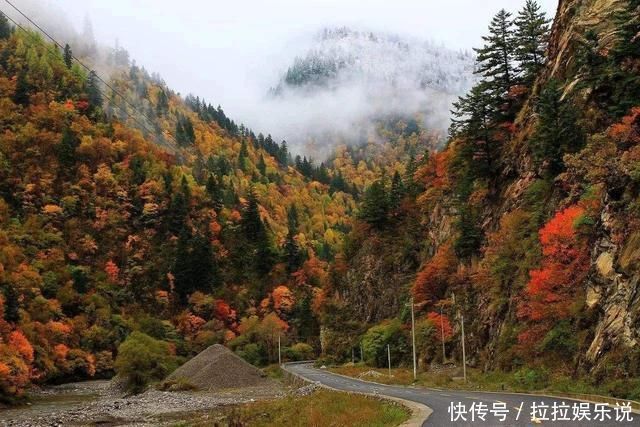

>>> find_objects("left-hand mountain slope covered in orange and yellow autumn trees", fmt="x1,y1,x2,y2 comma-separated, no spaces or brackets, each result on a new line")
0,17,400,397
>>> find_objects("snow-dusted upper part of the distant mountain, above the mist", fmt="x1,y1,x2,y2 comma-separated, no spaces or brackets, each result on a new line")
274,27,473,96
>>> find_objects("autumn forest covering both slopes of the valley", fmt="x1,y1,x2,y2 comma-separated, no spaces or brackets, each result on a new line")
0,0,640,400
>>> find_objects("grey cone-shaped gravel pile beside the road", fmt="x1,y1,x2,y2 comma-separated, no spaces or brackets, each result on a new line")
165,344,273,391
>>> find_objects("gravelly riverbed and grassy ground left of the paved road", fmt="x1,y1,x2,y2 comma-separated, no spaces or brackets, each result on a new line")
0,368,409,427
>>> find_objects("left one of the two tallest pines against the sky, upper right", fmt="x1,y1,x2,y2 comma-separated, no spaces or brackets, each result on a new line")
474,9,516,119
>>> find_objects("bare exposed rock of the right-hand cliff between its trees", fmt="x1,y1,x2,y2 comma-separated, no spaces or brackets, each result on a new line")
330,0,640,371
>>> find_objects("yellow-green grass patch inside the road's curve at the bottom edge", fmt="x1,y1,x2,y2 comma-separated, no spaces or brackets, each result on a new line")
162,390,409,427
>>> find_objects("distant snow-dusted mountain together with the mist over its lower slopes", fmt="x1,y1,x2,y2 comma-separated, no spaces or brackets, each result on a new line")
265,27,474,158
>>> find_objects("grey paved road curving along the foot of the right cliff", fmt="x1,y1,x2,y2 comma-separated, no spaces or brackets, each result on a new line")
285,363,640,427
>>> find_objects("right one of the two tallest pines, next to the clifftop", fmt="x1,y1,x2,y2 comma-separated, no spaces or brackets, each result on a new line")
514,0,550,85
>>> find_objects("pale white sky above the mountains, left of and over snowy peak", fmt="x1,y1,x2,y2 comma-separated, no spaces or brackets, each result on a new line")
5,0,558,154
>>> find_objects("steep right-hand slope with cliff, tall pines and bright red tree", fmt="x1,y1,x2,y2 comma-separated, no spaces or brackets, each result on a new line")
322,0,640,398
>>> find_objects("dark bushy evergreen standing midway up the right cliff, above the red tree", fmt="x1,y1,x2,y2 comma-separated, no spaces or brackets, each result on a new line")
531,80,585,175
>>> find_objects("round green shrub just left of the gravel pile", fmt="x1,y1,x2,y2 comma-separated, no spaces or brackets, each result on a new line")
114,332,177,393
